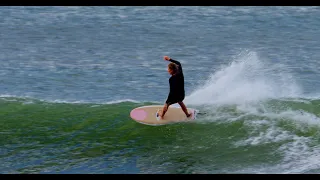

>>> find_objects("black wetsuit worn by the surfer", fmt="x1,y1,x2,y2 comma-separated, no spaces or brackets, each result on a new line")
166,59,185,105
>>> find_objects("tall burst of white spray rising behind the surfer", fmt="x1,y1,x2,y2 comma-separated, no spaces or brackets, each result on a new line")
185,52,301,105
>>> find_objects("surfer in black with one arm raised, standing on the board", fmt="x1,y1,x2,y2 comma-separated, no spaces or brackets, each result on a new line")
160,56,191,119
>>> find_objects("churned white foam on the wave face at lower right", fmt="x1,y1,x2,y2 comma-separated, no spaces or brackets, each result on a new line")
229,112,320,174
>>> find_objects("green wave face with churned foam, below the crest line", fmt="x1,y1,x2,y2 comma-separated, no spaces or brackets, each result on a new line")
0,92,320,173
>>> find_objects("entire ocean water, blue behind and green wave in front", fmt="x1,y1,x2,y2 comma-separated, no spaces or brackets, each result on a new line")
0,6,320,174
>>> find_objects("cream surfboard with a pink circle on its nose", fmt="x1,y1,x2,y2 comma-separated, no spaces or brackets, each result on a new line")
130,105,198,126
